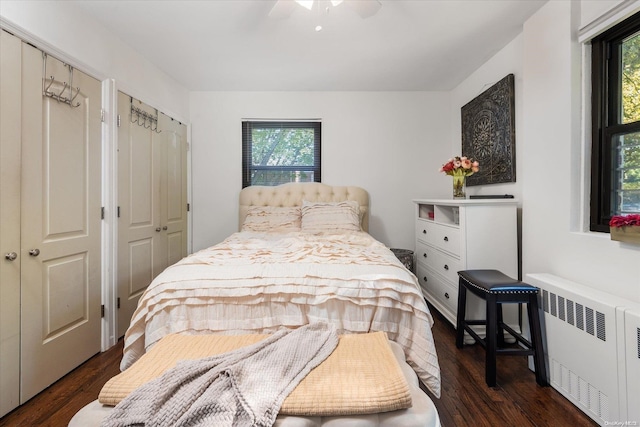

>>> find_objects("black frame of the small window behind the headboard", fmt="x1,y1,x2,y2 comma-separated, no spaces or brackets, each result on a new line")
242,120,322,188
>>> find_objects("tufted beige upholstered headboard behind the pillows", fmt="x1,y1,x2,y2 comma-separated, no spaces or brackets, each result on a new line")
238,182,369,232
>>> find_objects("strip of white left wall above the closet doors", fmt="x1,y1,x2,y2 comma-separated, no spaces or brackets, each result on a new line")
0,0,189,123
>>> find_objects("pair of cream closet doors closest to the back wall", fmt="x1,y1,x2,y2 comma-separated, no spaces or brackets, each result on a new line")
118,97,187,336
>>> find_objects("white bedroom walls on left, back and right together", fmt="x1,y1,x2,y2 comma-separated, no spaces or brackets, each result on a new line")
0,0,640,301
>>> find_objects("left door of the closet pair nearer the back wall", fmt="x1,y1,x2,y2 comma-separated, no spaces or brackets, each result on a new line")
118,92,162,336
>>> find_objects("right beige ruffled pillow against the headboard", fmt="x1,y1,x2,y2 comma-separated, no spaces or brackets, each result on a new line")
302,200,362,234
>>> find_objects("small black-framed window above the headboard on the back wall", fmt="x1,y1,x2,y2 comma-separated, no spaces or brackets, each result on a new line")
242,121,320,188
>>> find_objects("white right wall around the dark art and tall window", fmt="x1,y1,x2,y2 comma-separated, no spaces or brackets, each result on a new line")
451,1,640,302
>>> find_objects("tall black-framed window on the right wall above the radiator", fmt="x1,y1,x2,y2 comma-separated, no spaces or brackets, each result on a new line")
590,13,640,232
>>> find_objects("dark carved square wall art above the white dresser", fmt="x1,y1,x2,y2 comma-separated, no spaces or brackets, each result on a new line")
461,74,516,186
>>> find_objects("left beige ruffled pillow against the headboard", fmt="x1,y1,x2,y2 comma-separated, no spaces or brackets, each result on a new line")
241,206,301,232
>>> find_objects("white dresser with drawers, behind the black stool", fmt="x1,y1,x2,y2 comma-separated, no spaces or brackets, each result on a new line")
413,199,518,326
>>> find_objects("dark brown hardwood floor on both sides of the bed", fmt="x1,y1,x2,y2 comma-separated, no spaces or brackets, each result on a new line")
0,310,597,427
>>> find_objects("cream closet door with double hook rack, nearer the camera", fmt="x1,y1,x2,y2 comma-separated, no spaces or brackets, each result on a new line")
20,43,102,402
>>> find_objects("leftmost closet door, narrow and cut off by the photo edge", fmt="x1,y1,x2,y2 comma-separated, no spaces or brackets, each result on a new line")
0,31,22,417
